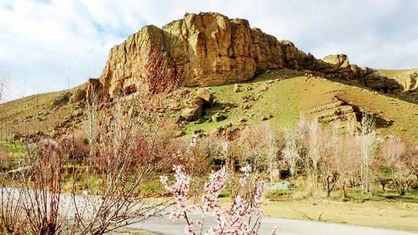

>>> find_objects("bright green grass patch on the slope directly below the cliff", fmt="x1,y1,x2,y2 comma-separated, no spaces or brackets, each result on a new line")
184,70,305,135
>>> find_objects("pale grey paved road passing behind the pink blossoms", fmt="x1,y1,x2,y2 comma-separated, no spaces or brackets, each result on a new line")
129,213,418,235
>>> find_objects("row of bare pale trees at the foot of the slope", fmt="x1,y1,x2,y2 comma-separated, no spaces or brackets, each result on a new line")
176,114,418,196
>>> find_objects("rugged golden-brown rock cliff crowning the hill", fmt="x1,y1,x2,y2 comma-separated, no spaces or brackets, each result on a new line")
100,13,398,97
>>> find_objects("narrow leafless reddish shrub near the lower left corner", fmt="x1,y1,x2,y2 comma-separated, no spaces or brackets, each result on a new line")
22,140,64,235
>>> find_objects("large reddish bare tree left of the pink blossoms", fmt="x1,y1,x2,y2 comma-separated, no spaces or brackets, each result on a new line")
68,90,168,234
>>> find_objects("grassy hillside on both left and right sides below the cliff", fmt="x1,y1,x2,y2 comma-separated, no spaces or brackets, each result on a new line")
0,69,418,143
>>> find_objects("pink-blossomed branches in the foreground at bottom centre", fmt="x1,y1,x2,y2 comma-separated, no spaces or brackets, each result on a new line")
161,166,275,235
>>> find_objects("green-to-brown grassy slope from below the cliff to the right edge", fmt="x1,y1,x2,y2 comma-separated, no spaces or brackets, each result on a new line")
178,69,418,143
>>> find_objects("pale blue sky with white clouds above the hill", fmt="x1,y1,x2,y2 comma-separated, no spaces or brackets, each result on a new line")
0,0,418,100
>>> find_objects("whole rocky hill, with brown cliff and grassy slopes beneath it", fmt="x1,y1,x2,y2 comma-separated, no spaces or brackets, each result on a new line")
0,13,418,143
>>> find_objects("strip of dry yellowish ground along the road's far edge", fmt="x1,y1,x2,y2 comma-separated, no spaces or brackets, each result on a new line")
263,200,418,231
